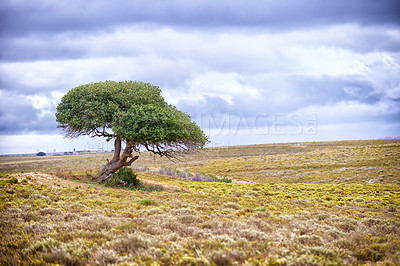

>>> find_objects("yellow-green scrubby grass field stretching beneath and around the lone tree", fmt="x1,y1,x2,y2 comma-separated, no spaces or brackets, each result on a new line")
0,140,400,265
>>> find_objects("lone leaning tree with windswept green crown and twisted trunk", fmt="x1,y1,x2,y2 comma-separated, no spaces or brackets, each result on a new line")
56,81,209,181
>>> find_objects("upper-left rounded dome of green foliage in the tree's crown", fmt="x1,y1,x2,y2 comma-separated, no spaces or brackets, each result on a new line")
56,81,164,137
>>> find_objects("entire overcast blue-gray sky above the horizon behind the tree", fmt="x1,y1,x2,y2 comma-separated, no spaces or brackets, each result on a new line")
0,0,400,155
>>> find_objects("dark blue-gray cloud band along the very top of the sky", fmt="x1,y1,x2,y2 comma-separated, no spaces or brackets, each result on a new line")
0,0,400,38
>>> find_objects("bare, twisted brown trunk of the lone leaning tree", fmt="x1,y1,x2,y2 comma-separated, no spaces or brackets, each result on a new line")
94,137,139,182
